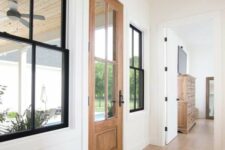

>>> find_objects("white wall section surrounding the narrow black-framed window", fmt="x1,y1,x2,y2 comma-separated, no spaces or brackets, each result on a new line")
121,0,153,150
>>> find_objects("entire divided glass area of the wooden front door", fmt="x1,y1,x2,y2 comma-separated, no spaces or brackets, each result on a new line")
94,0,116,121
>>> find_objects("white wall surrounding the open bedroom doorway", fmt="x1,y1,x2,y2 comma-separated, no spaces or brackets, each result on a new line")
150,0,225,150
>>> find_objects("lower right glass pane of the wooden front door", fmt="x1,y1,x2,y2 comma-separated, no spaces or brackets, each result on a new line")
108,64,116,118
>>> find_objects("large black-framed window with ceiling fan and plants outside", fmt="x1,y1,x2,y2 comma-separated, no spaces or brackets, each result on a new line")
0,0,69,142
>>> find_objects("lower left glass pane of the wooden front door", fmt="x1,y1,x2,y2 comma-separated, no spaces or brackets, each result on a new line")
95,61,105,121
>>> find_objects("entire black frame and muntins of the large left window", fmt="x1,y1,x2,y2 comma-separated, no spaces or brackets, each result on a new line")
0,0,69,142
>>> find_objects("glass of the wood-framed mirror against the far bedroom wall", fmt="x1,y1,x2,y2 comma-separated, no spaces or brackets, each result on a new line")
209,80,214,117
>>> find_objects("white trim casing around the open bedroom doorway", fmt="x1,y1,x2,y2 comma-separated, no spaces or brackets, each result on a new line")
161,11,221,146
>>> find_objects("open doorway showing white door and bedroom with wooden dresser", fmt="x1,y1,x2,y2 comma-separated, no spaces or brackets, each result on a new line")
164,12,219,150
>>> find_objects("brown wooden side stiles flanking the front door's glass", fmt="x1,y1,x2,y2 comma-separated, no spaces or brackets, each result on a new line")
88,0,123,150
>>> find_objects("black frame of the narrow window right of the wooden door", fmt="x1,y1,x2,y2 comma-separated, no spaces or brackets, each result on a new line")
129,24,145,113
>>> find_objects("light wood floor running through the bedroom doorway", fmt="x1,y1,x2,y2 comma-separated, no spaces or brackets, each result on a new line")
144,119,213,150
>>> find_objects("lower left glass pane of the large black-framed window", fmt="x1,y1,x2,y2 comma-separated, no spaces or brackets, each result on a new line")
0,39,31,135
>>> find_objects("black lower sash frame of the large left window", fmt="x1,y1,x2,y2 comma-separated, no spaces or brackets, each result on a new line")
0,32,69,142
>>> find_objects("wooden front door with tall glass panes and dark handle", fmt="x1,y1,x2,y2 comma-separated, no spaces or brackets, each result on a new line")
89,0,123,150
